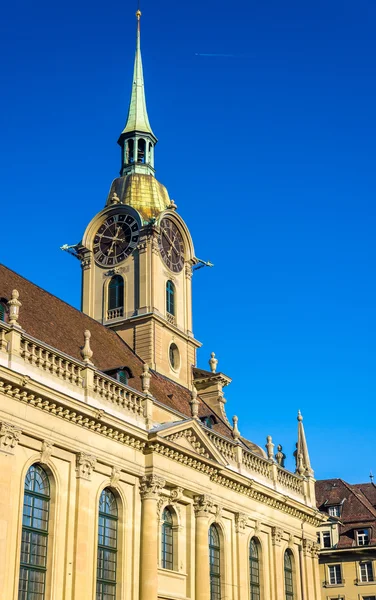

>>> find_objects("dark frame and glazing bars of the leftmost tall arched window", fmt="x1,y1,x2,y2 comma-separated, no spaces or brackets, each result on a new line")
18,463,52,600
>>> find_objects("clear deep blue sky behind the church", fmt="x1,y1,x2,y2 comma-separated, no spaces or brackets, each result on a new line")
0,0,376,482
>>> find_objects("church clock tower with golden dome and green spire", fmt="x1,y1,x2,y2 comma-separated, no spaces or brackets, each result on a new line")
77,11,201,387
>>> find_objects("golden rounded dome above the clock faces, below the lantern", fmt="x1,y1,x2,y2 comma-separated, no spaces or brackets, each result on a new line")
106,173,171,222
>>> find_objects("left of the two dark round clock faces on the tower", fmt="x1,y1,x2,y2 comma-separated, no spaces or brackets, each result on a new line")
93,213,140,266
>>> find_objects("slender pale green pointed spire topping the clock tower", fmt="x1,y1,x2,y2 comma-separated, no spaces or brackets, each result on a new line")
122,10,155,137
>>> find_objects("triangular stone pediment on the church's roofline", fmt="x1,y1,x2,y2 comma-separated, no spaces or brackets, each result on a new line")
150,419,228,466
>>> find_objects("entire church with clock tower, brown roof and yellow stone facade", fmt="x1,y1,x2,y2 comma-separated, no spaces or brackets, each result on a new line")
0,11,323,600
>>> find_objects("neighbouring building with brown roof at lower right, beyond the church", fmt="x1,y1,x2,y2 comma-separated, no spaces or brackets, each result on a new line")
316,479,376,600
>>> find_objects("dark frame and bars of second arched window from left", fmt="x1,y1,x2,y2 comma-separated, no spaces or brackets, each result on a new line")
95,486,121,600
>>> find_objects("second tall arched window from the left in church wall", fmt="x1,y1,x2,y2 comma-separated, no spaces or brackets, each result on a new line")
96,488,118,600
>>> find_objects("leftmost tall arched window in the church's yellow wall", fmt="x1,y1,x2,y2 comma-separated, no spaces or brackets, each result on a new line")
18,465,50,600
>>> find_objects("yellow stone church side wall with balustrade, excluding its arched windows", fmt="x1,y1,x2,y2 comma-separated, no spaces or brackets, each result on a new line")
0,324,321,600
